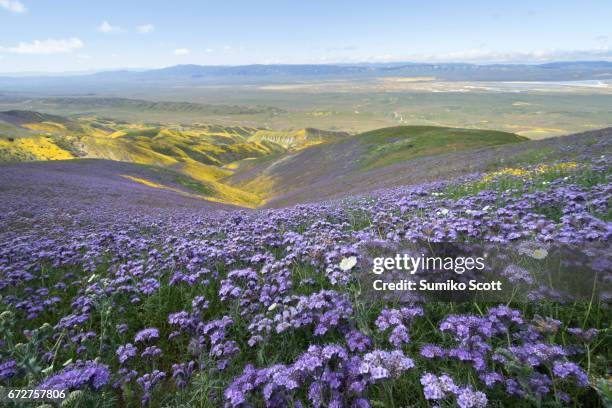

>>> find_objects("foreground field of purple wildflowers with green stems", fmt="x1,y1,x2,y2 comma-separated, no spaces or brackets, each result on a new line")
0,137,612,408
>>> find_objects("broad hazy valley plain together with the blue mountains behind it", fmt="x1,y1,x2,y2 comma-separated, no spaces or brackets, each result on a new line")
0,61,612,139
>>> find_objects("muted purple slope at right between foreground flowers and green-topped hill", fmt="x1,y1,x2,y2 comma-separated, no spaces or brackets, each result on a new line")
235,128,612,208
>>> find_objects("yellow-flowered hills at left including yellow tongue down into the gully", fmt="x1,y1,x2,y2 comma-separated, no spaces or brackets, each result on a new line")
0,110,356,207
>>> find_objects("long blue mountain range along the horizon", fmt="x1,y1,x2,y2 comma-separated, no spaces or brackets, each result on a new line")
0,61,612,91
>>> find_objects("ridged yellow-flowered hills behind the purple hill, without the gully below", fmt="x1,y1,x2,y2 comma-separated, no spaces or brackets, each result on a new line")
0,110,349,166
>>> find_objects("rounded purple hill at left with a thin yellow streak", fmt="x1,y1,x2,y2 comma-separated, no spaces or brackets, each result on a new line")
0,159,236,225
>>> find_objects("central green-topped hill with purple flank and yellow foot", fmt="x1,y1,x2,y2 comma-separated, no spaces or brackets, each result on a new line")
226,126,527,199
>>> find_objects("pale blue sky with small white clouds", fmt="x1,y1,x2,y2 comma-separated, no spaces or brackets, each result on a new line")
0,0,612,72
